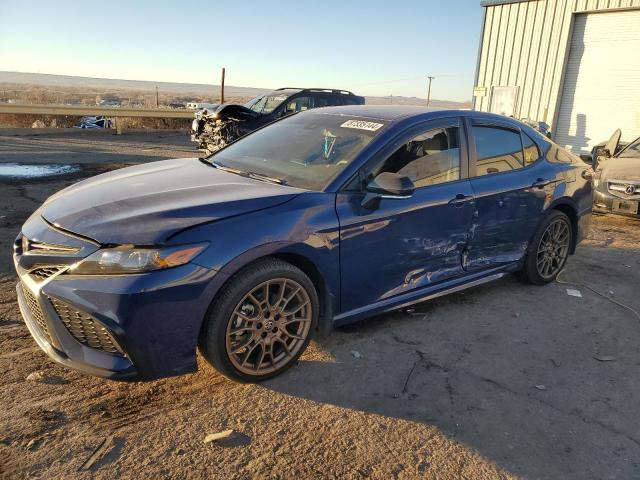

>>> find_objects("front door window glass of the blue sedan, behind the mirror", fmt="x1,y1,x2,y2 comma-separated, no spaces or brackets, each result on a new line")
372,127,460,188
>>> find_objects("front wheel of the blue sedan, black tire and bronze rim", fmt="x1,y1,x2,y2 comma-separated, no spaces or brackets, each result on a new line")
200,258,319,382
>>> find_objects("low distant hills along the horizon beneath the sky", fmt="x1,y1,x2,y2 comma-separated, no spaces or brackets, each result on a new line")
0,71,471,108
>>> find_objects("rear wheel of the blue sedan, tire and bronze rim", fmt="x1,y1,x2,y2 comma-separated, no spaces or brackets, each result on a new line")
518,210,574,285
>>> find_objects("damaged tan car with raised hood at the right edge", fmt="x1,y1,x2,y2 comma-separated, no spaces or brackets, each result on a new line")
583,129,640,218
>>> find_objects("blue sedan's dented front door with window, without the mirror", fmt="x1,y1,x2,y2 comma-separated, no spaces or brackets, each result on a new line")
336,118,474,312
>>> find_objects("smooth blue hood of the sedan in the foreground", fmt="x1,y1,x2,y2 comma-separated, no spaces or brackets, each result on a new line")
40,158,303,245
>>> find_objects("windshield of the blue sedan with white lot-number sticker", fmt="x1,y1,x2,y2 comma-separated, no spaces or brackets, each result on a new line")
208,111,386,190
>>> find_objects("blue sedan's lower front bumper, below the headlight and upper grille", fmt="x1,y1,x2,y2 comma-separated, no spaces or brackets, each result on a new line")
16,264,220,380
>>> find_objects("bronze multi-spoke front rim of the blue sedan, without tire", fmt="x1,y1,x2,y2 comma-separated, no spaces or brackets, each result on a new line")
225,278,313,376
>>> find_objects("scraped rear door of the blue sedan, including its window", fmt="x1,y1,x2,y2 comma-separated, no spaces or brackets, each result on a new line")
463,119,555,271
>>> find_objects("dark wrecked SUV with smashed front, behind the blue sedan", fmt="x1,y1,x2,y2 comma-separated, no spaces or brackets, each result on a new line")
191,88,364,153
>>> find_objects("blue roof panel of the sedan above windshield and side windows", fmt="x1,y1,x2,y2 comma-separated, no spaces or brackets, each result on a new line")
305,105,520,124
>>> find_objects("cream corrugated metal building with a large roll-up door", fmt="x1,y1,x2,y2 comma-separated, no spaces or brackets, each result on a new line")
474,0,640,153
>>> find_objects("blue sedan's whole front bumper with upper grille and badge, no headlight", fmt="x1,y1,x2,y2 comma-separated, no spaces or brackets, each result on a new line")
14,215,224,380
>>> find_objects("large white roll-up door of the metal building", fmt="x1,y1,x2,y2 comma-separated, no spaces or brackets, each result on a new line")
553,10,640,154
